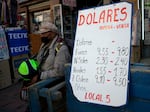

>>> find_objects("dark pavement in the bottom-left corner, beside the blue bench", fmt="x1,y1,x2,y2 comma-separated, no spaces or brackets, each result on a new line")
0,81,27,112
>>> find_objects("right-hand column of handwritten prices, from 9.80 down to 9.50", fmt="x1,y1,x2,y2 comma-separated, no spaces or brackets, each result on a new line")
113,46,129,87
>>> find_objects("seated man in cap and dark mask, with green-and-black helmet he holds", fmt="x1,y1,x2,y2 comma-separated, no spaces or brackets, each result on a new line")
18,22,71,110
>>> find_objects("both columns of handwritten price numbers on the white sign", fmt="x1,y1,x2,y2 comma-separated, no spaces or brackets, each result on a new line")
95,46,129,87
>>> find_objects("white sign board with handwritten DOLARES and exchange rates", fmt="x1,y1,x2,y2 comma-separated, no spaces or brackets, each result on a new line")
70,2,132,107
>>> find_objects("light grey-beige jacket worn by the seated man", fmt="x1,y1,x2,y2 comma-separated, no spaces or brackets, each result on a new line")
37,36,71,79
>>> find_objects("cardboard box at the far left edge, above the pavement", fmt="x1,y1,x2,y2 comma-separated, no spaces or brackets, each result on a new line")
0,60,12,89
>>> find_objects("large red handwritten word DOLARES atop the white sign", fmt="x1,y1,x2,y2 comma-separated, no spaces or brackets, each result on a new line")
78,7,128,26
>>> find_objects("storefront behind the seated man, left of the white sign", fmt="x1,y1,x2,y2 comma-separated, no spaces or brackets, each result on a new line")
18,0,76,55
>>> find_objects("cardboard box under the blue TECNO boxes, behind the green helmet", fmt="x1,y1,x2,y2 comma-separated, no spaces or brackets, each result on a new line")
12,54,29,82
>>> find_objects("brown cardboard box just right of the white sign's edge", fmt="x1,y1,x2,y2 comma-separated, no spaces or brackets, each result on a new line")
130,46,141,63
